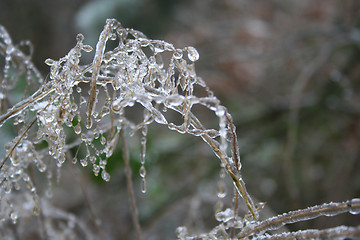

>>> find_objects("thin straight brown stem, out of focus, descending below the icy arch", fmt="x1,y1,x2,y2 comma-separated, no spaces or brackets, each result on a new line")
120,130,141,240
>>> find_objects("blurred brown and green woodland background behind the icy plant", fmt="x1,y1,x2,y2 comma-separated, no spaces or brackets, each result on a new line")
0,0,360,239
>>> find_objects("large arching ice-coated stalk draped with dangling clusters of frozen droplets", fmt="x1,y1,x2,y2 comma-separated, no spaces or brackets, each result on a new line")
0,16,256,236
